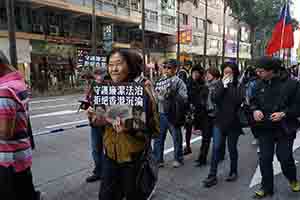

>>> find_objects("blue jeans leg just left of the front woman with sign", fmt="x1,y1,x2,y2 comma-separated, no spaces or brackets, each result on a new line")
91,127,103,177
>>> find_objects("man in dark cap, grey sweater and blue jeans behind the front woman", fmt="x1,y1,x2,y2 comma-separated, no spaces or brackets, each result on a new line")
153,59,188,168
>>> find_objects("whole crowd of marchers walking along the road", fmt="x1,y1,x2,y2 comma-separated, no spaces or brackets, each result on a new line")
0,50,300,200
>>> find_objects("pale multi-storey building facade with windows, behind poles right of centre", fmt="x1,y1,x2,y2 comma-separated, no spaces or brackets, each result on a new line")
146,0,251,68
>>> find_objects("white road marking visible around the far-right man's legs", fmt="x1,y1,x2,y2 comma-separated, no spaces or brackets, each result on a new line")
249,134,300,188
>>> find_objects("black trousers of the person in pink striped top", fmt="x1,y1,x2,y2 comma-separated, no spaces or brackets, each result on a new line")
0,167,38,200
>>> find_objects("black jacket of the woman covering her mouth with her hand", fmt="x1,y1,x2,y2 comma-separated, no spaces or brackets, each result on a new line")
213,82,243,134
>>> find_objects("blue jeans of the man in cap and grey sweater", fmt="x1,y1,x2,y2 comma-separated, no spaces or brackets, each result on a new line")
153,113,183,162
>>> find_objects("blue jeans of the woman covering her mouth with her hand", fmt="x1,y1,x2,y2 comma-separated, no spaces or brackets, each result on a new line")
209,126,240,176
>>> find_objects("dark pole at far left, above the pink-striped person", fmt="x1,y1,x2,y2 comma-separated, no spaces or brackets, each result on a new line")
6,0,18,69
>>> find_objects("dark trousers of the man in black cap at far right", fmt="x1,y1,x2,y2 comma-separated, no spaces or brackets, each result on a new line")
258,131,297,193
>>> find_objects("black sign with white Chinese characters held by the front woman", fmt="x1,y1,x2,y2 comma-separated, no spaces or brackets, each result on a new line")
93,83,146,131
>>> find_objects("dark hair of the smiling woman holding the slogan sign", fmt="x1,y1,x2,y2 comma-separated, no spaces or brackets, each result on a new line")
107,49,144,81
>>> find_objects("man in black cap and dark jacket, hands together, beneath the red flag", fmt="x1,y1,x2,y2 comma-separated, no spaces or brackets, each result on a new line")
251,57,300,199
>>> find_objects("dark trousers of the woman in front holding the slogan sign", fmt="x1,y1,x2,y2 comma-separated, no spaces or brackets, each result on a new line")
99,157,145,200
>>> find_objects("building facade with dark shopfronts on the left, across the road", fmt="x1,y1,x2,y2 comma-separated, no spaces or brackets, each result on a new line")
0,0,141,92
